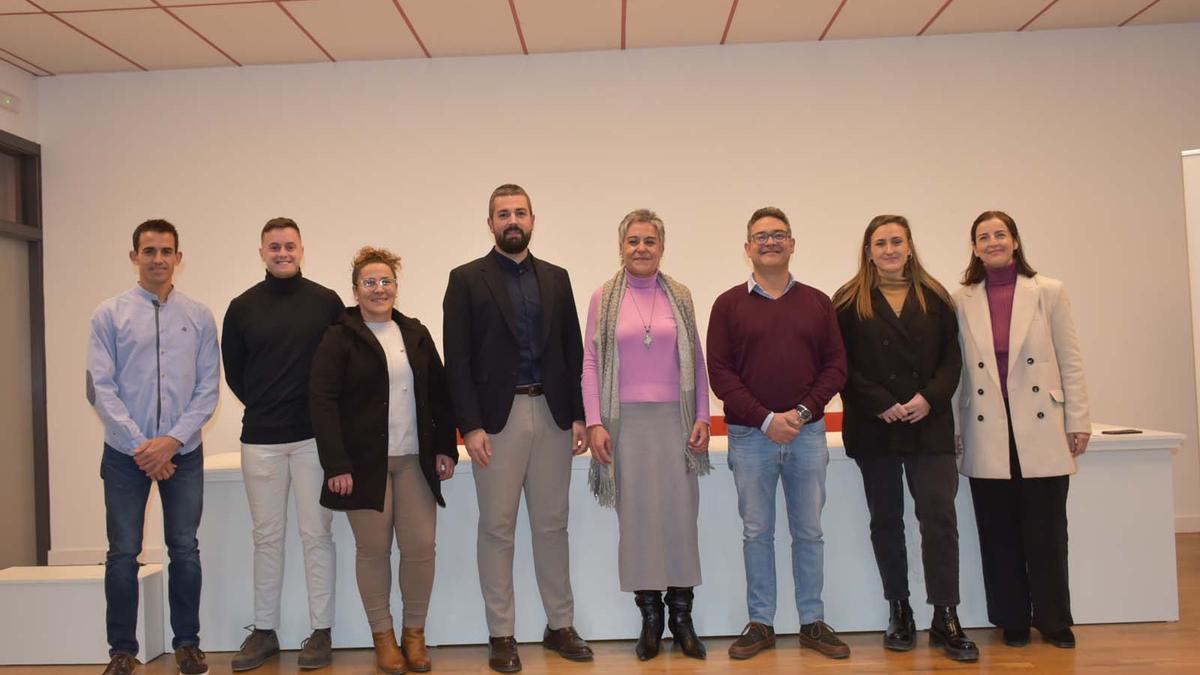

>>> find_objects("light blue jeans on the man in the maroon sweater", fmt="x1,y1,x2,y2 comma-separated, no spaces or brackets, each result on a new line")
728,419,829,626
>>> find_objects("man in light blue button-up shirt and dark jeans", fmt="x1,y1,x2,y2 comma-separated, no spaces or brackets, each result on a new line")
88,220,221,675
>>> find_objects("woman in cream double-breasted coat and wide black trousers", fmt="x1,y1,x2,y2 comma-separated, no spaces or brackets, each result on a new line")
953,211,1091,649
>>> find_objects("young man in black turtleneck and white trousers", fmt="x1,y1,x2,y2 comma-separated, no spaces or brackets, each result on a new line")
221,217,344,670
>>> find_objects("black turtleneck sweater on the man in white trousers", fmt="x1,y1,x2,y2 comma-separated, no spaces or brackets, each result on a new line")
221,273,346,444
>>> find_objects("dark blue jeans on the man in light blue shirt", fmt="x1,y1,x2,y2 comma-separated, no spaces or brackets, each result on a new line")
100,444,204,656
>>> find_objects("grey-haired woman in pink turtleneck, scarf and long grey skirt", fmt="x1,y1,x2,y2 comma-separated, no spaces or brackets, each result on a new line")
583,209,710,661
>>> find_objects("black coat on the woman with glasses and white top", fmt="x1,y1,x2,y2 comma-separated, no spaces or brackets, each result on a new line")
308,306,458,512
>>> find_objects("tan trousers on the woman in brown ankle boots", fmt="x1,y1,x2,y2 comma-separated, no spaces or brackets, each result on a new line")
346,455,438,633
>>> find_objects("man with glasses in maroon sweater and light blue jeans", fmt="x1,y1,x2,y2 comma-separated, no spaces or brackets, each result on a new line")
707,207,850,658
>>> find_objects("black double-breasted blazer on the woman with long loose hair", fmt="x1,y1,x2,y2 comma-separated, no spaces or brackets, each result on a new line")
838,287,962,458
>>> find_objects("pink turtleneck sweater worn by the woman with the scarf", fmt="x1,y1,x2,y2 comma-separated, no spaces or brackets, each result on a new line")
583,269,709,426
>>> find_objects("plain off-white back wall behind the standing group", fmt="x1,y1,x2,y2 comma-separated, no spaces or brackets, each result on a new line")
40,24,1200,550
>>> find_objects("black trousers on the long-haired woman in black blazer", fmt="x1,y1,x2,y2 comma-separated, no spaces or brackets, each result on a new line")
856,454,959,605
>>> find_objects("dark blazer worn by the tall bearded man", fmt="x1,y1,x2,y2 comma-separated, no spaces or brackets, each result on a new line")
442,249,583,435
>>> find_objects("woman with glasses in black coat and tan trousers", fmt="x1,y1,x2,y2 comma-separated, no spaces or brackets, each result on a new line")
310,246,458,674
